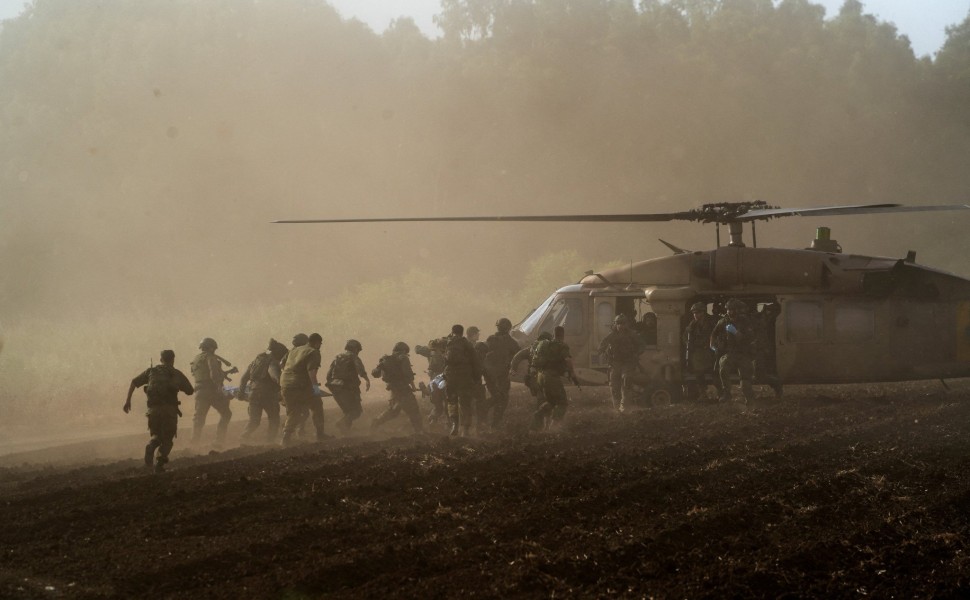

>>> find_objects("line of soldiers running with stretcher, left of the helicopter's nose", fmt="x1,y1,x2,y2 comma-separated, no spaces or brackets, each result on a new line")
123,318,536,472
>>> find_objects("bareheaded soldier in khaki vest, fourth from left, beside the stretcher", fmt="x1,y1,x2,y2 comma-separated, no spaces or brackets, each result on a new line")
280,333,325,448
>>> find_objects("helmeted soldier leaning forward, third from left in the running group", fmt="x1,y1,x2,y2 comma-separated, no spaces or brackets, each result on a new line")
237,338,287,444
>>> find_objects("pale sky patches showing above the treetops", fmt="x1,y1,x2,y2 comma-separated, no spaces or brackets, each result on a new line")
0,0,970,55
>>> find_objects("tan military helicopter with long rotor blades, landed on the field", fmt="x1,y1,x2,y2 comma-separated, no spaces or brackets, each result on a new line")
276,201,970,404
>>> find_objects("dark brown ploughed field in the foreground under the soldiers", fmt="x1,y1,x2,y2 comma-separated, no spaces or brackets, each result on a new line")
0,382,970,598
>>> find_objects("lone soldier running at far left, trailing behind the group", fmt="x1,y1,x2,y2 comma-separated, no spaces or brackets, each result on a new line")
122,350,194,473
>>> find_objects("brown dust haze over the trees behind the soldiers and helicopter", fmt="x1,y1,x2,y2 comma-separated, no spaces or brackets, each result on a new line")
0,0,970,440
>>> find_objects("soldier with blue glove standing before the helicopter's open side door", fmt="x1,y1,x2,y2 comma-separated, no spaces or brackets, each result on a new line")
710,298,755,402
